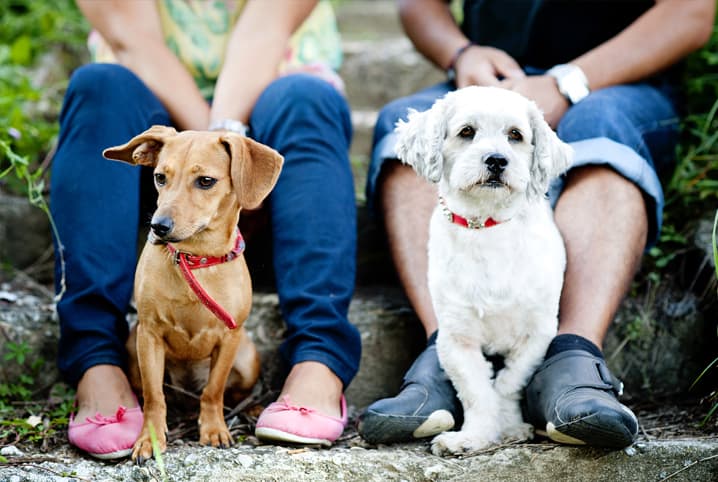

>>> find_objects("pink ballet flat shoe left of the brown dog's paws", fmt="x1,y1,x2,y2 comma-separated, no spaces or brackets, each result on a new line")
67,405,144,460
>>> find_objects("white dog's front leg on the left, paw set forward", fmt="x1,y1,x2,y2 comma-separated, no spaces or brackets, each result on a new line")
431,329,501,455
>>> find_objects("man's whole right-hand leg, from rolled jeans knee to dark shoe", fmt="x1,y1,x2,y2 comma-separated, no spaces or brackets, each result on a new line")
526,84,677,448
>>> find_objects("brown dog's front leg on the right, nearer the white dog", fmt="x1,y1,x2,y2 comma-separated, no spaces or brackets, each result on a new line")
199,334,241,447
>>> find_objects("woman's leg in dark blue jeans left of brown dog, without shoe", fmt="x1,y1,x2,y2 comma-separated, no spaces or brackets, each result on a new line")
50,64,169,420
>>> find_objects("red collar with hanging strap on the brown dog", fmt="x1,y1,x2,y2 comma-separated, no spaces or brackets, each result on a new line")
166,229,244,330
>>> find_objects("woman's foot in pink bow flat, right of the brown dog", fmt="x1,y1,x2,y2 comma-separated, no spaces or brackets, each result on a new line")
255,362,347,447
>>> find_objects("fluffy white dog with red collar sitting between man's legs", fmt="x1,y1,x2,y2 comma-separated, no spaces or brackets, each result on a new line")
396,86,573,455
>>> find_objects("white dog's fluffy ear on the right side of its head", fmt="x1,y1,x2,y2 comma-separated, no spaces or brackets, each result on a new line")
528,102,573,196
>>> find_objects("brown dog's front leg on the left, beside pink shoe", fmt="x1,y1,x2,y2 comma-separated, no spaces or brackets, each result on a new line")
132,322,167,462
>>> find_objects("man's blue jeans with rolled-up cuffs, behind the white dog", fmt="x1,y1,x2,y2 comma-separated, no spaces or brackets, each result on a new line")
366,77,679,246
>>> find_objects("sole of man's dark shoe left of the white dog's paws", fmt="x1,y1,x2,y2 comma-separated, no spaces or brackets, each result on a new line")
359,410,455,444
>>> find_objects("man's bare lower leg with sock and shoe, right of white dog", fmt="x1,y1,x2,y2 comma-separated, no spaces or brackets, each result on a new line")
527,166,648,448
